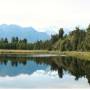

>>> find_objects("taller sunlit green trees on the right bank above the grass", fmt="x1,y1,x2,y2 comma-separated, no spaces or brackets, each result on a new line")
53,25,90,51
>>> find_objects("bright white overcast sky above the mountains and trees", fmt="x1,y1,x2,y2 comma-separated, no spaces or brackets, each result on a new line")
0,0,90,31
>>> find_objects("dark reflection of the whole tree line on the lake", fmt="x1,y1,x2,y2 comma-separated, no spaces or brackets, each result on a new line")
0,57,90,84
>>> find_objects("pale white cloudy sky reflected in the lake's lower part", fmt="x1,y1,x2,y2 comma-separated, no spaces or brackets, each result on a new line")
0,70,89,88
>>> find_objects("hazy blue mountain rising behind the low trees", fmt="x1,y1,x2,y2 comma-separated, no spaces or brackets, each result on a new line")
0,24,50,42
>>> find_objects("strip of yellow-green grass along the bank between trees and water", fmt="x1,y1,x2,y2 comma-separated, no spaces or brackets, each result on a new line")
0,49,90,60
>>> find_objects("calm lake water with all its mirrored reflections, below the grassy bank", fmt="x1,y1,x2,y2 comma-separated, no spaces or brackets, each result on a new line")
0,56,90,88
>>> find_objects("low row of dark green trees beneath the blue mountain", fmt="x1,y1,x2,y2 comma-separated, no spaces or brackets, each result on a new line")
0,37,49,50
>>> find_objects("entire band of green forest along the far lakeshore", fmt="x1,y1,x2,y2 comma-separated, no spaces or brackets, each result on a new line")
0,25,90,51
